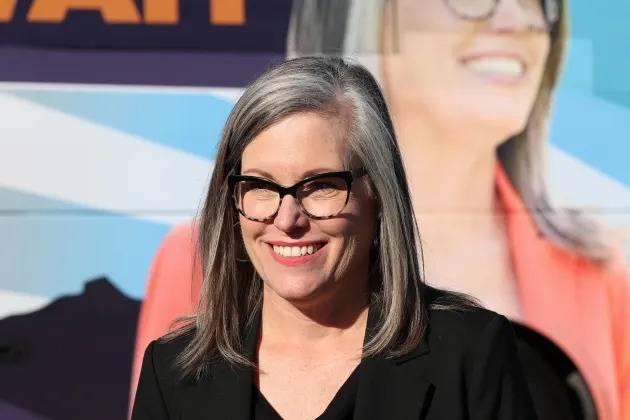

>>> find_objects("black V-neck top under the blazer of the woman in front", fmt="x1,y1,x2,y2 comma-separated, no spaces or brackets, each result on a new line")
251,365,361,420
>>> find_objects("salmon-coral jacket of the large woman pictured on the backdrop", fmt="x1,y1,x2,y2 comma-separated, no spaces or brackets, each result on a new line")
131,165,630,420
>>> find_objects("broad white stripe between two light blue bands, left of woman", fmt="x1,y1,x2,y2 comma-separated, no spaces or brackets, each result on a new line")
0,93,212,224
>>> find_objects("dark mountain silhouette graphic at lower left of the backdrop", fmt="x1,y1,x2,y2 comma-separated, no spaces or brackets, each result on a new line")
0,277,140,420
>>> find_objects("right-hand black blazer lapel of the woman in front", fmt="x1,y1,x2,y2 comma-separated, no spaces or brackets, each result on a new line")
354,307,435,420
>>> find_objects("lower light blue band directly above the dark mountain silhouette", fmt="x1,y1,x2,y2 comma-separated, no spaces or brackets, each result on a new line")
0,188,169,299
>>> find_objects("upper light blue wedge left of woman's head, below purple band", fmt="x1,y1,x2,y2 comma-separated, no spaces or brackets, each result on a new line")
5,89,233,158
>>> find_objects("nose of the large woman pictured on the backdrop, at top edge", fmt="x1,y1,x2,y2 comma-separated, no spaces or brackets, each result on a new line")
488,0,546,32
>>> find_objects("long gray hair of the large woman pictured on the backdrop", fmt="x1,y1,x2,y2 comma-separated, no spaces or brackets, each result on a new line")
287,0,613,263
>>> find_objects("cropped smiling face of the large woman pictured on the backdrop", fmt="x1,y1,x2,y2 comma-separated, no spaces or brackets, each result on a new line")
382,0,550,141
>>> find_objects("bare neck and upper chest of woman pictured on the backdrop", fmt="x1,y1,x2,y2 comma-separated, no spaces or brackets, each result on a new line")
396,108,520,319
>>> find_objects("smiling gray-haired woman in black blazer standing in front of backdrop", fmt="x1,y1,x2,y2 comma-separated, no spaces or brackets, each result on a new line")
132,57,534,420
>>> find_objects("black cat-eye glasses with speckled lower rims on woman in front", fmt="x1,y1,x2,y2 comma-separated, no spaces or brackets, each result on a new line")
228,168,367,222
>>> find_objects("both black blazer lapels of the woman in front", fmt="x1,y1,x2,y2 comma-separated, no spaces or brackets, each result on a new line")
182,306,433,420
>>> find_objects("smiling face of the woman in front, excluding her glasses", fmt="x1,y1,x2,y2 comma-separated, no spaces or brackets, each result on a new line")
240,113,375,302
